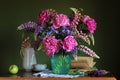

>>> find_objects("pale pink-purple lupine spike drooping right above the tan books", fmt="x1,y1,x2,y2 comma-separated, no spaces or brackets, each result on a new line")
79,45,100,59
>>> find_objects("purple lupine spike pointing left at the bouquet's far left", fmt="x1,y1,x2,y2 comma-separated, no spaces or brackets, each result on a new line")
18,21,38,31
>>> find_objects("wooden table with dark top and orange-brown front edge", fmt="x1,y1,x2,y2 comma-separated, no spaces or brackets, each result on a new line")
0,71,117,80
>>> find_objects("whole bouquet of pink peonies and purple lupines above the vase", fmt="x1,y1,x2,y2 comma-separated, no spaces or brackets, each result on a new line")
18,8,99,58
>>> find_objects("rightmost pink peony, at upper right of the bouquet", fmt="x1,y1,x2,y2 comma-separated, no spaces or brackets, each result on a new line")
83,16,96,34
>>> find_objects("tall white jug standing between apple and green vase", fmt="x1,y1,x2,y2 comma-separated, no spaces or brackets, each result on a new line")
23,48,37,71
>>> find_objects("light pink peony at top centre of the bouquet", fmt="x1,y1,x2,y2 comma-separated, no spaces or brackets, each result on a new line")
52,14,70,29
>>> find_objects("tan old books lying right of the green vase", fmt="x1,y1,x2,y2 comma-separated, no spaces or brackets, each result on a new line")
71,56,96,72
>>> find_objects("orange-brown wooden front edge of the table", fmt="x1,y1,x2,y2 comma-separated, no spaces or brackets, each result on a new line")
0,77,116,80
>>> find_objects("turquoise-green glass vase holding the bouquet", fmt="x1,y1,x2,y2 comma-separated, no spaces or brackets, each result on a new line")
51,54,71,74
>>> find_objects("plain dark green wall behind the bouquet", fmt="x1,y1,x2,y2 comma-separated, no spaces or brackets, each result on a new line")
0,0,120,77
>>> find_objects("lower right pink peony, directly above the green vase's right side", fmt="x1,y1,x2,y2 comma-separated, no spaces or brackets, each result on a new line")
62,36,78,52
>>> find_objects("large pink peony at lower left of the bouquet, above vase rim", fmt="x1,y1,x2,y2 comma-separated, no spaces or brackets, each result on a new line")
43,36,60,56
